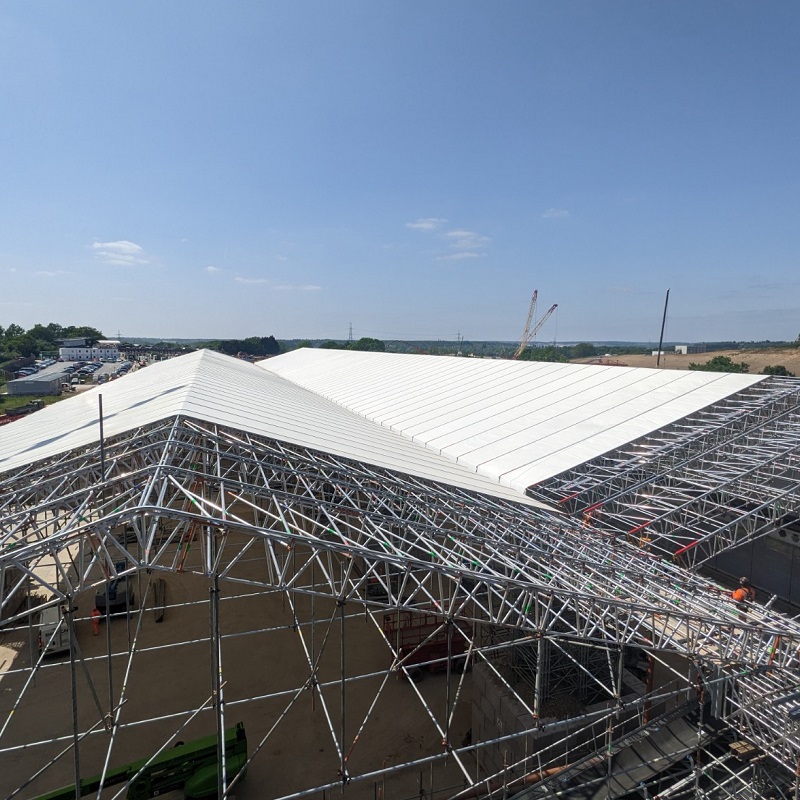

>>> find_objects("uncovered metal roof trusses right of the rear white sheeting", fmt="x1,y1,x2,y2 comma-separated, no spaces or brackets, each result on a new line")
529,378,800,567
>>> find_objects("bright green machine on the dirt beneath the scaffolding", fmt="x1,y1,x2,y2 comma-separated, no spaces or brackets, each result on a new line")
37,722,247,800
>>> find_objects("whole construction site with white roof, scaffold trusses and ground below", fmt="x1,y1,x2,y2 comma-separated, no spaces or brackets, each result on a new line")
0,348,800,800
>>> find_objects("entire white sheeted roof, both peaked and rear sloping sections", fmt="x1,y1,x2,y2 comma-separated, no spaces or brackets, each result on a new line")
0,349,762,500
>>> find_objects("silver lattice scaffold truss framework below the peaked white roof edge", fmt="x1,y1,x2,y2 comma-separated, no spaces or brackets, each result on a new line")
0,410,800,796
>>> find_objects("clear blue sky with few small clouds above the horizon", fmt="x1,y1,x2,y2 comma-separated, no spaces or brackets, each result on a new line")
0,0,800,341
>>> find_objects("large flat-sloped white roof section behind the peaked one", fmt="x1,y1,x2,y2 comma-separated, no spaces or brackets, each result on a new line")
259,349,763,492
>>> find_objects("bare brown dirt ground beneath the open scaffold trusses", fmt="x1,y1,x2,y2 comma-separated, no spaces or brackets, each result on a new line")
0,544,474,800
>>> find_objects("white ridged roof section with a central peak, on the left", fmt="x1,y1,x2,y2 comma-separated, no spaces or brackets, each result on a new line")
0,350,541,505
